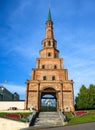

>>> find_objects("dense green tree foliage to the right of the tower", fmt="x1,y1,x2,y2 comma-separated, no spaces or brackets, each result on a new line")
75,84,95,109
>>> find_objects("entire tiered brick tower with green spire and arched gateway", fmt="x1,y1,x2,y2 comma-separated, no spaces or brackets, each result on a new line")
25,10,74,112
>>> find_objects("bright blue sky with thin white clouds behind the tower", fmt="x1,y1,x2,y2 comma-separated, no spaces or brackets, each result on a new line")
0,0,95,99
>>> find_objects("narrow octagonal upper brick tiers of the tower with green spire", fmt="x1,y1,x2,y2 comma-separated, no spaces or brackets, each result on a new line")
40,9,59,58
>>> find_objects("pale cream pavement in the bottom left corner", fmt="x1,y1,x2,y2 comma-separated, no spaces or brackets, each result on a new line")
0,118,28,130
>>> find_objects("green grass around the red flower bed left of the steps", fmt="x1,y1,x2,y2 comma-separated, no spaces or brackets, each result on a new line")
0,112,32,122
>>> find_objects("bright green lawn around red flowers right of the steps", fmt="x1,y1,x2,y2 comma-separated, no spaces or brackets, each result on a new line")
66,110,95,125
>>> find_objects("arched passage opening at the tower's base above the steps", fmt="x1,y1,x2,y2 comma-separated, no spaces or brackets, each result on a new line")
41,87,57,111
